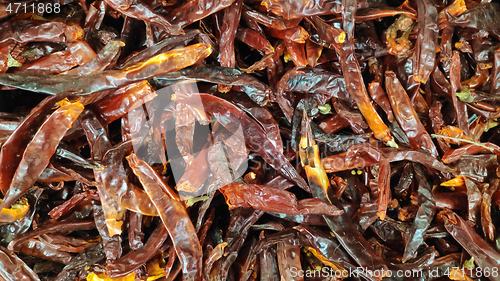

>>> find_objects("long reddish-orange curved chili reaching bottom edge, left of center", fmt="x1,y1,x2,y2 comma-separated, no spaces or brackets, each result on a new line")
127,154,203,281
